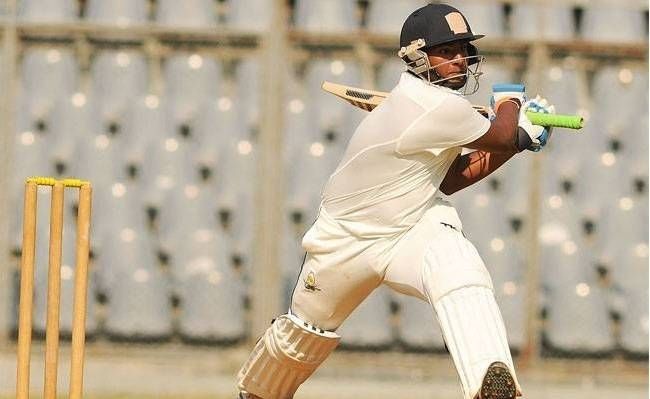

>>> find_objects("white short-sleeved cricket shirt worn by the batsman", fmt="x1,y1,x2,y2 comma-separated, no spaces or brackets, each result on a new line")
303,72,490,253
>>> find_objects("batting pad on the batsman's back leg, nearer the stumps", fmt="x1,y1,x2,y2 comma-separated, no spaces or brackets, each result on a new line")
237,314,341,399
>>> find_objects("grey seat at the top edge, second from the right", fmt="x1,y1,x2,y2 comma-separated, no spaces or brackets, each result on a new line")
510,2,575,40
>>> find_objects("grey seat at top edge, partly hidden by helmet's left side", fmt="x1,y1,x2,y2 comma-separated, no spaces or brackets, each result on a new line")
366,0,427,35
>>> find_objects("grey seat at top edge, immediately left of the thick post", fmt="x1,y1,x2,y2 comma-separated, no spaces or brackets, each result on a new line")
227,0,273,32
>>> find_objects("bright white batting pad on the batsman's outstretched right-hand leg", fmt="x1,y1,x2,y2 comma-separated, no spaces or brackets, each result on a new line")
433,286,521,399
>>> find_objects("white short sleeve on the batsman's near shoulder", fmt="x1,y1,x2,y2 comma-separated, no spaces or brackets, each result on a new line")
396,94,490,155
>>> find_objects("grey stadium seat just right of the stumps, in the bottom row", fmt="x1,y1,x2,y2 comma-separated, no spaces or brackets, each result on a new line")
94,182,172,340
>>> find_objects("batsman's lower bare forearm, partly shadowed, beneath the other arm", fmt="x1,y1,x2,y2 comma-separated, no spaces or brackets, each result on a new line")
440,150,517,195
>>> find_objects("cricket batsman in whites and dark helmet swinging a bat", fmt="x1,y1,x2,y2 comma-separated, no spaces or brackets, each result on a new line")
238,4,554,399
